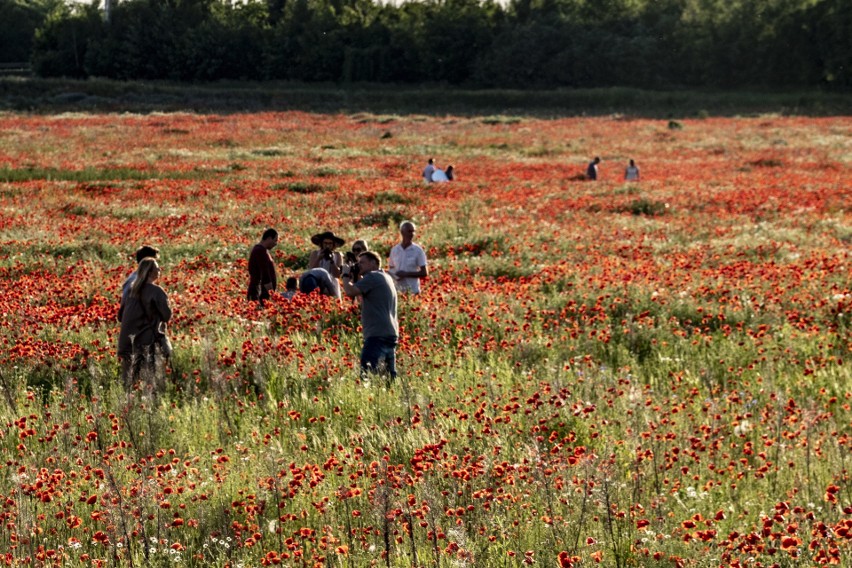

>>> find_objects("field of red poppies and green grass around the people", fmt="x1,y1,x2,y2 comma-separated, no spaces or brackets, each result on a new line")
0,112,852,568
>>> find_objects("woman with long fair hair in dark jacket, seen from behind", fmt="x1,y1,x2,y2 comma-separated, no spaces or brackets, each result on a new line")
118,257,172,390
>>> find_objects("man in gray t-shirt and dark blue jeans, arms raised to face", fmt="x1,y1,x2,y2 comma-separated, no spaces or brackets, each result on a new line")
341,251,399,380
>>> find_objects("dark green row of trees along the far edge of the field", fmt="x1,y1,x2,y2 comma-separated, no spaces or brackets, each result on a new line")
0,0,852,89
